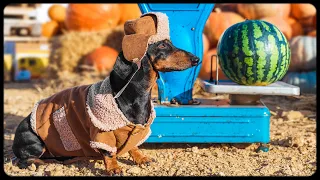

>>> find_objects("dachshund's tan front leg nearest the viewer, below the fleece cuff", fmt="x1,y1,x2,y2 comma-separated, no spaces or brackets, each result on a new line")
99,149,123,176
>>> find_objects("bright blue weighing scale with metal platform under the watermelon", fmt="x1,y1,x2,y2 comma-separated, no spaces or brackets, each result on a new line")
139,3,300,151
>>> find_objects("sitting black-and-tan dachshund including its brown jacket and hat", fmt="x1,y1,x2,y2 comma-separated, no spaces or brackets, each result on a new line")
12,13,199,175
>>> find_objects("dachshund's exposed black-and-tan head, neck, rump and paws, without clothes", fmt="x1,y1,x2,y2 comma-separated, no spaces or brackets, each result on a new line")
12,40,199,175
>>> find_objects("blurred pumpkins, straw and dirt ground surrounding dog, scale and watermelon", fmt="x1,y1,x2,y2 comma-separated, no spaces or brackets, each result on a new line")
3,4,317,176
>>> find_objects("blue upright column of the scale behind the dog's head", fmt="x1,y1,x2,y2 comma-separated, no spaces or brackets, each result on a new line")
138,3,214,104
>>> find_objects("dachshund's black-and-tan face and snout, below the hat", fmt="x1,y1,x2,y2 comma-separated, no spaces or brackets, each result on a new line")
146,40,199,72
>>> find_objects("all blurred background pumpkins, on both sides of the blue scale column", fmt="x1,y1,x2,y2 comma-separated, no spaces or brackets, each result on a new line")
42,4,316,92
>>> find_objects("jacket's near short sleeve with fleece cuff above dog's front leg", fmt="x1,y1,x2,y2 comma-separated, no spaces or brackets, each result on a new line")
90,127,117,153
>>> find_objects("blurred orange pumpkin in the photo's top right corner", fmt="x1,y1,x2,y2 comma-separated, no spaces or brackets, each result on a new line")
291,3,317,20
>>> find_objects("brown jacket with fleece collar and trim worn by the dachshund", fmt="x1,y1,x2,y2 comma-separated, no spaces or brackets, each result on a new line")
30,77,155,157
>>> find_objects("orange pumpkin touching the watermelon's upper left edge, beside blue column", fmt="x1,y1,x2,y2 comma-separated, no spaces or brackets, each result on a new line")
204,8,245,47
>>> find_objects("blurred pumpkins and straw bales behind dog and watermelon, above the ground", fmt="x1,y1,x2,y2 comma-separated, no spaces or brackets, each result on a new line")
4,4,316,93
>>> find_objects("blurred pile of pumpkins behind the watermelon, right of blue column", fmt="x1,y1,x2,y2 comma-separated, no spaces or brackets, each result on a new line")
199,3,316,92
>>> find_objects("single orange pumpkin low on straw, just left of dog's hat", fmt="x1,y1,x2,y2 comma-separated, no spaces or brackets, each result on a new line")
86,46,118,72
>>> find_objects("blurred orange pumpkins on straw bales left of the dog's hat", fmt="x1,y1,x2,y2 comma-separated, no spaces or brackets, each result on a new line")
42,4,141,72
